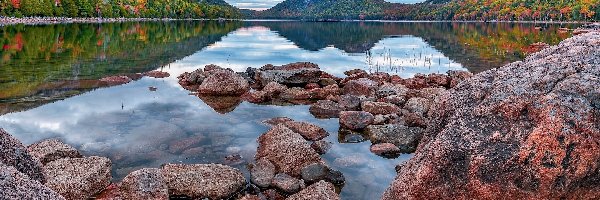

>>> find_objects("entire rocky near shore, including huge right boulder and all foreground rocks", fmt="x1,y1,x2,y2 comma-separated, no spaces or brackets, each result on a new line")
0,23,600,200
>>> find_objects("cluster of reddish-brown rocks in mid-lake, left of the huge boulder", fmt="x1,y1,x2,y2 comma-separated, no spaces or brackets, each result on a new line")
179,62,472,157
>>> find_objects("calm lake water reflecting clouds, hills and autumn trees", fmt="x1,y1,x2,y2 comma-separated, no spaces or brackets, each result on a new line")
0,21,577,199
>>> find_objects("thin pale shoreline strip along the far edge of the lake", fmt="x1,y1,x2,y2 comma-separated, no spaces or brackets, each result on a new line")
0,17,596,27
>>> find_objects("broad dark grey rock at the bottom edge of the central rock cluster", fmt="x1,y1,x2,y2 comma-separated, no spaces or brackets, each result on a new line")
366,124,423,153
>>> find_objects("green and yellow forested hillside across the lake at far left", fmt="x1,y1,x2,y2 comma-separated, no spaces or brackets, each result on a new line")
0,0,241,18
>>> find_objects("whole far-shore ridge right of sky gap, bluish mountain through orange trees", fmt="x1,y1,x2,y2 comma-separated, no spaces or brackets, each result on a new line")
249,0,600,21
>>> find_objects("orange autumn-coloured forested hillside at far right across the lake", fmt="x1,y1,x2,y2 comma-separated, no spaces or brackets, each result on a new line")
384,0,600,21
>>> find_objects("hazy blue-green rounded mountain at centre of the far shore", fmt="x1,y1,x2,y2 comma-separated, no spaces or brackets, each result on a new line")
255,0,391,20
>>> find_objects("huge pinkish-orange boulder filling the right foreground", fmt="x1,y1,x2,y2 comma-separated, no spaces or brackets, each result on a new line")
382,33,600,200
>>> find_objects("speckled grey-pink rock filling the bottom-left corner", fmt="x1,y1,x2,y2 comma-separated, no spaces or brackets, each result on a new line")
0,165,64,200
